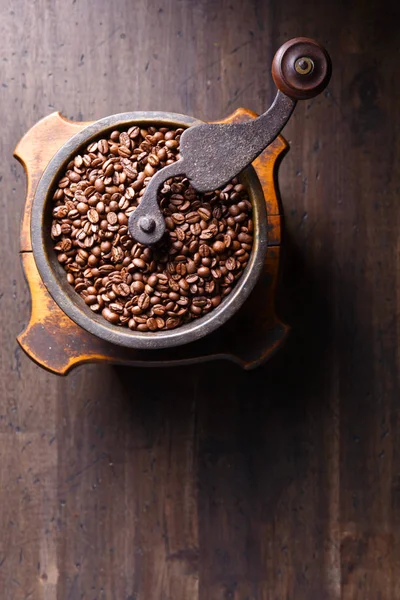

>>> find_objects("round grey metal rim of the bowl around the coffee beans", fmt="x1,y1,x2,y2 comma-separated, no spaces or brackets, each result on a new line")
31,111,267,350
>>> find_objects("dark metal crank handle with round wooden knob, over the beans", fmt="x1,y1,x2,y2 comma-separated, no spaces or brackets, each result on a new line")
128,38,332,245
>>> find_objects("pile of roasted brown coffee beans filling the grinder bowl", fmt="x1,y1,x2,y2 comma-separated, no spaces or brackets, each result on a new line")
51,126,253,332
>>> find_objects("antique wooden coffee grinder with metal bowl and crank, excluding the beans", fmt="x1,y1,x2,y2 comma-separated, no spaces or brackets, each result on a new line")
15,38,331,374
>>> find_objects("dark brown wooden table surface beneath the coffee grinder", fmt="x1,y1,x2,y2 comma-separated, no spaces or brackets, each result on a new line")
0,0,400,600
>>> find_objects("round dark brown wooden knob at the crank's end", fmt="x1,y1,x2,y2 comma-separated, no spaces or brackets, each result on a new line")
272,38,332,100
